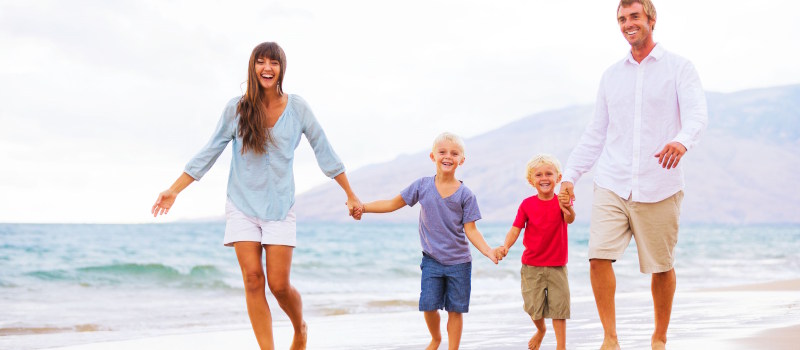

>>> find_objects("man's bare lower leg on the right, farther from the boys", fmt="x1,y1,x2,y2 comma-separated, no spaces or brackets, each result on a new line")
650,269,677,349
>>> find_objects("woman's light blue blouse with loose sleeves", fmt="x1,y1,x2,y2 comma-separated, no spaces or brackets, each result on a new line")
184,94,344,220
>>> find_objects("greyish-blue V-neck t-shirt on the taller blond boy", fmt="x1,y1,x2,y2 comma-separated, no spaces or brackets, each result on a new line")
400,176,481,265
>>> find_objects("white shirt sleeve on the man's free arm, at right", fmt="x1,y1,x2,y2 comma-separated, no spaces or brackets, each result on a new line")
673,61,708,150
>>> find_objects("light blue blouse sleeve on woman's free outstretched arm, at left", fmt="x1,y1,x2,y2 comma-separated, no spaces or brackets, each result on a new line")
183,98,239,181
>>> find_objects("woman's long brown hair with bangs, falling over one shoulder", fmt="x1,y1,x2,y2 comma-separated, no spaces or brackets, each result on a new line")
236,42,286,154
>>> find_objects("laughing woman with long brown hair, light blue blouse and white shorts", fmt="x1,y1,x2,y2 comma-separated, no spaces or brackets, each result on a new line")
152,42,361,349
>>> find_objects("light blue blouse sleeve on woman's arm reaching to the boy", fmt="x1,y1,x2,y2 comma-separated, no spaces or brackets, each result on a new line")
298,98,345,178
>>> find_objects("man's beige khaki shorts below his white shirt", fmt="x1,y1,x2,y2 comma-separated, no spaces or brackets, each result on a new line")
589,186,683,273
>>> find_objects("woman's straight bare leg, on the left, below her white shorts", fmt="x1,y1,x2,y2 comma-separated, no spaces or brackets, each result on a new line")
234,242,275,350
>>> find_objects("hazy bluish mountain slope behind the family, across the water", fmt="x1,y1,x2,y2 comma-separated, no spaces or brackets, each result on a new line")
295,85,800,225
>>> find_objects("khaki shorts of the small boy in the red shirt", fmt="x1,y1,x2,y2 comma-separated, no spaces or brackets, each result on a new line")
520,264,569,320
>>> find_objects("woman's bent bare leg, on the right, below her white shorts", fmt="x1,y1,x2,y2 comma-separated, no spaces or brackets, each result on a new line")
264,245,308,350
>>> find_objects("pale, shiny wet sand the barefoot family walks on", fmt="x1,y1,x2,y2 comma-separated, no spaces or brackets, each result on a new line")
45,279,800,350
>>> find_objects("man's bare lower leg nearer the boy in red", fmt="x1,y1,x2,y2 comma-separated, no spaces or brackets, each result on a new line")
589,259,619,350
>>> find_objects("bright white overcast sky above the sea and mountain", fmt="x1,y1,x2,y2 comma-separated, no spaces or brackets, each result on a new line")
0,0,800,223
